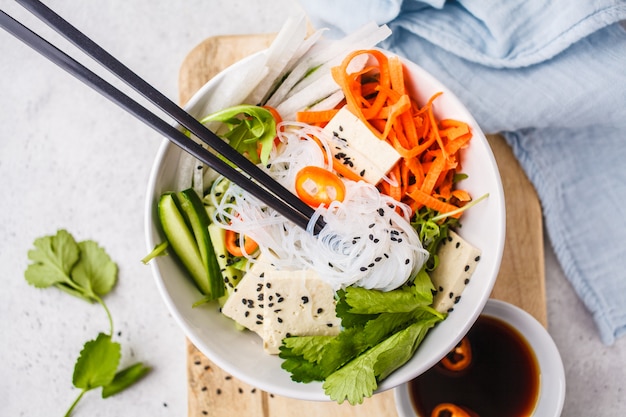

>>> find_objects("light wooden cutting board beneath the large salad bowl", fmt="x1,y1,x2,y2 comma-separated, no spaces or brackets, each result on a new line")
179,34,547,417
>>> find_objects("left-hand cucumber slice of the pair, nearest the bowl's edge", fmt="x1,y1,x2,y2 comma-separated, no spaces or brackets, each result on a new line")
158,193,210,294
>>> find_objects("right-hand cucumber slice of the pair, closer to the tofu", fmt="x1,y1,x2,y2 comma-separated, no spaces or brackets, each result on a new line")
178,188,224,300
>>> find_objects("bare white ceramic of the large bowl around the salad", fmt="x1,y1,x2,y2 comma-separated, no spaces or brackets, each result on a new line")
146,48,505,401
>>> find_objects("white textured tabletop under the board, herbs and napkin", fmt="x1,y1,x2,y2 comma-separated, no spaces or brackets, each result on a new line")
0,0,626,417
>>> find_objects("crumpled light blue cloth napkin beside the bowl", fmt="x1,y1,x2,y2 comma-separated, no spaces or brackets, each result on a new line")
300,0,626,345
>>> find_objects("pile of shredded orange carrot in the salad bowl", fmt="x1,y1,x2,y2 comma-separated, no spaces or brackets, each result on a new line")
297,50,472,217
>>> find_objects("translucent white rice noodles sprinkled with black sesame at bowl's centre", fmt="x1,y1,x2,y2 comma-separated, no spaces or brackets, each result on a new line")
211,122,428,291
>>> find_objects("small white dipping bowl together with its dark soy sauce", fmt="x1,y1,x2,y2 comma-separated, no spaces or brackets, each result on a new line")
394,299,565,417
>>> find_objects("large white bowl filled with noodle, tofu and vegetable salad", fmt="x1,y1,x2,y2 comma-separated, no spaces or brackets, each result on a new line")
146,19,505,404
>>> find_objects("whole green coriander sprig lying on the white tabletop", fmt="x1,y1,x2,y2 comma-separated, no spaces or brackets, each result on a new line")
24,230,150,417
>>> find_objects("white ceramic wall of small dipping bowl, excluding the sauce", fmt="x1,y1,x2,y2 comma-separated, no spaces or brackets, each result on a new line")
394,299,565,417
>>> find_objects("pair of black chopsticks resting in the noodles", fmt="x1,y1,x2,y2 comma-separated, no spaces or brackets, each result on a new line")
0,0,324,234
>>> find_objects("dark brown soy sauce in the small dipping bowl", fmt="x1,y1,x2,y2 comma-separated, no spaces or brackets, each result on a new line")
409,316,540,417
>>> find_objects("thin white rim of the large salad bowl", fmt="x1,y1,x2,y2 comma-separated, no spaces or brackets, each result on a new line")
144,48,506,401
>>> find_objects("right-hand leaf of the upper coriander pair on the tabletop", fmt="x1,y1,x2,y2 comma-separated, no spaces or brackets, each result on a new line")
71,240,117,298
